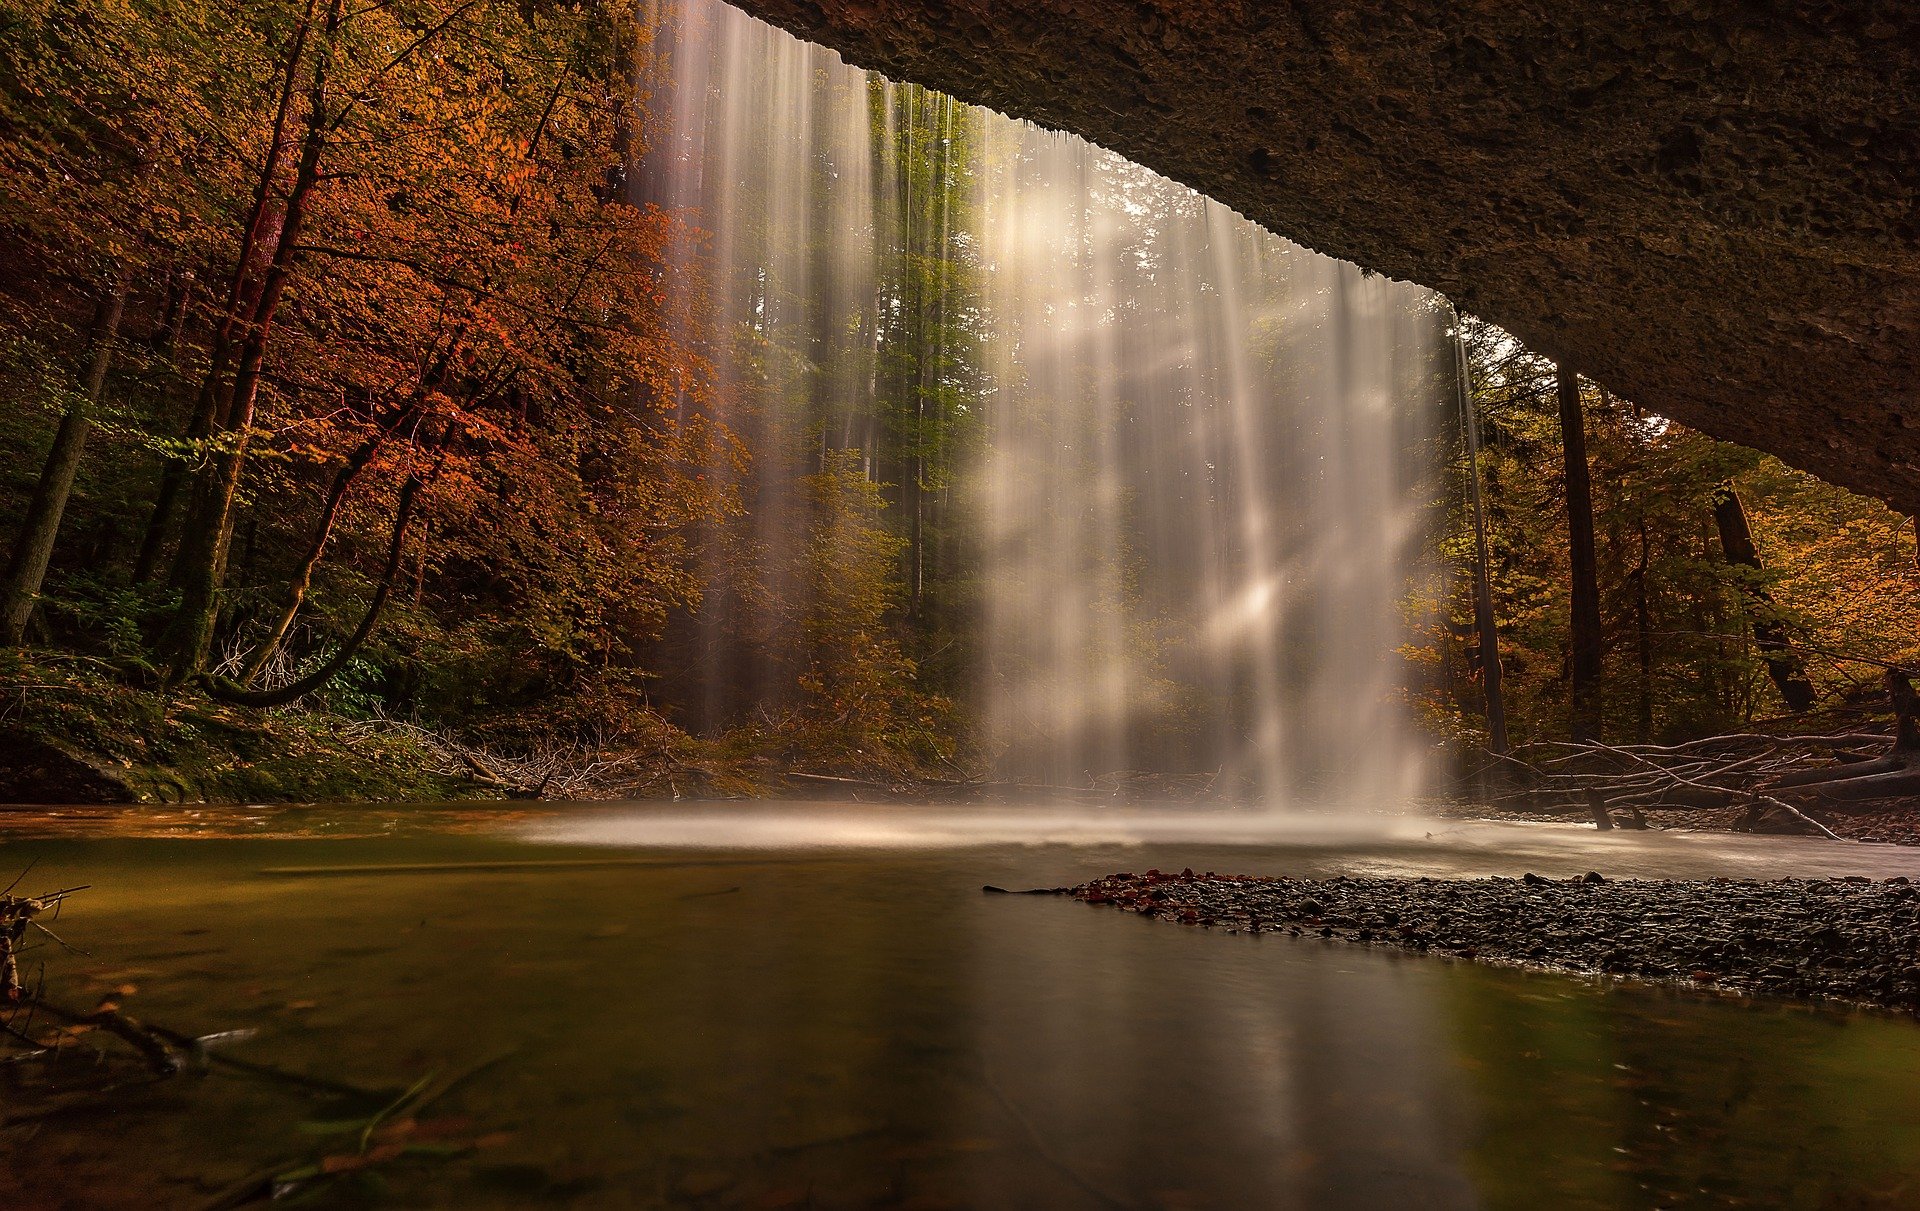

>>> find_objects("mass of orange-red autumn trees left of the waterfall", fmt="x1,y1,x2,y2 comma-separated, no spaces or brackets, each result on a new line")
0,0,733,740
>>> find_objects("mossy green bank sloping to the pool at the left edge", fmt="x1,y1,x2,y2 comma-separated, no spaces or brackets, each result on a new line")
0,654,488,802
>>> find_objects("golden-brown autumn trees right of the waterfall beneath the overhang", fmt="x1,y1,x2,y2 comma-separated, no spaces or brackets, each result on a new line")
1430,317,1920,759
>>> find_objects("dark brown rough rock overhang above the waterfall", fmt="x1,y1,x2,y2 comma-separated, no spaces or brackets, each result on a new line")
737,0,1920,511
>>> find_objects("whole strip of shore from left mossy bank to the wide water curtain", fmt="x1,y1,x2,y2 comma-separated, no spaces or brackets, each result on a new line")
0,654,972,804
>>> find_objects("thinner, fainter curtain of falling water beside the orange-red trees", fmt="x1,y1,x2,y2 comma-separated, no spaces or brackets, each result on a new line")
634,0,900,729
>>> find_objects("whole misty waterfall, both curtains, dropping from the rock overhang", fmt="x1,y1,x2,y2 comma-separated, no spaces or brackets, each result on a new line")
639,0,1450,804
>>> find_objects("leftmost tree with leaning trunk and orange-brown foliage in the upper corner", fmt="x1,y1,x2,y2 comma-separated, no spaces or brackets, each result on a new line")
0,2,248,643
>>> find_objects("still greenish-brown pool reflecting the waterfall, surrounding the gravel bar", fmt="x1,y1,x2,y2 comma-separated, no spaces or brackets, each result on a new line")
0,806,1920,1209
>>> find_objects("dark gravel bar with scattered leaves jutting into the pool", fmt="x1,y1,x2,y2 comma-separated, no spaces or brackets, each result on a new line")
1071,869,1920,1013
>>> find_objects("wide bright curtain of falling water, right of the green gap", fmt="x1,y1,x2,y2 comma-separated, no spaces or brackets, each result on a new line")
979,130,1444,806
